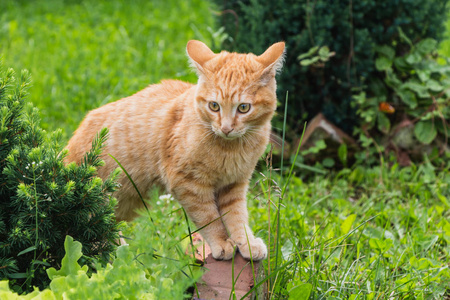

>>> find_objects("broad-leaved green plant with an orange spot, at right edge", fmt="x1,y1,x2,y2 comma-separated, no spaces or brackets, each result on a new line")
354,30,450,166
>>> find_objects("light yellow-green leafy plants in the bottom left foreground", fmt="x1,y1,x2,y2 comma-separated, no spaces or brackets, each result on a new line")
0,196,202,299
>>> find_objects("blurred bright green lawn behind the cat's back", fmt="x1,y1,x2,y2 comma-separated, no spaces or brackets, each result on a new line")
0,0,214,139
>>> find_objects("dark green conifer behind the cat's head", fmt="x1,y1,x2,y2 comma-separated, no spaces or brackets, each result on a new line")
216,0,448,133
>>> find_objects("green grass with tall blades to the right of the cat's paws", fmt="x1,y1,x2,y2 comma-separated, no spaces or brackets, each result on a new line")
248,164,450,299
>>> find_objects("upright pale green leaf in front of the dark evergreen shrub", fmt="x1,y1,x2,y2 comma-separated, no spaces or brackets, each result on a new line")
47,235,88,280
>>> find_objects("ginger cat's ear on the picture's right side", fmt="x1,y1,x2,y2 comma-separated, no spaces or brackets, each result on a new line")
256,42,285,84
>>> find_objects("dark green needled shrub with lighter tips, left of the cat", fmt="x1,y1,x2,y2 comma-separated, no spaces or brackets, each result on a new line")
0,63,118,290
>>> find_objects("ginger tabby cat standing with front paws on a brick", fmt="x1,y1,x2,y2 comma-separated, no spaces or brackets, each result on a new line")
66,40,285,260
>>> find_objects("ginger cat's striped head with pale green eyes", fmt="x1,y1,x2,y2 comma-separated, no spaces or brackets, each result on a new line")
187,41,285,140
